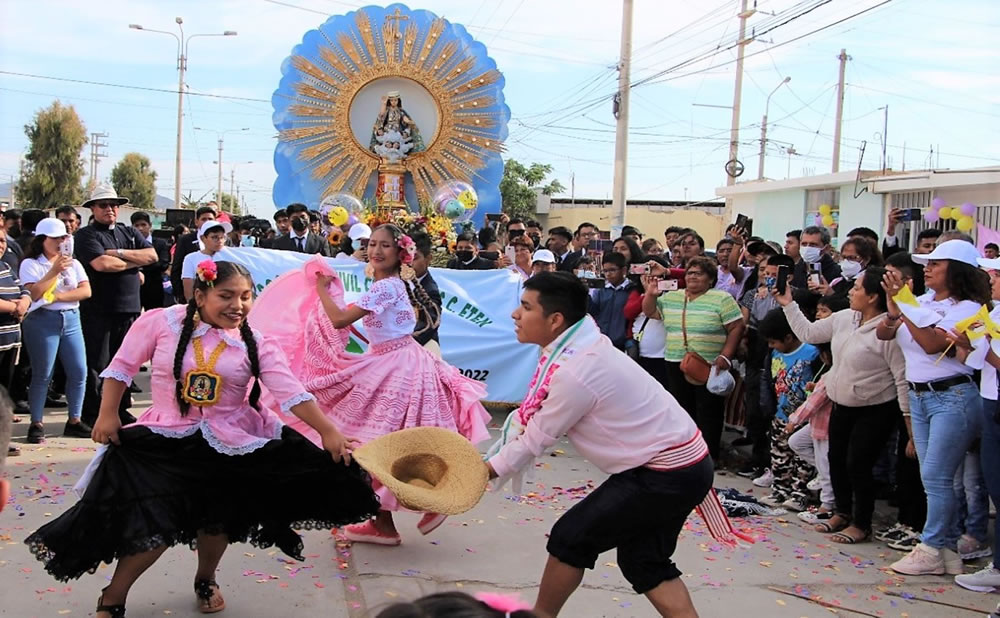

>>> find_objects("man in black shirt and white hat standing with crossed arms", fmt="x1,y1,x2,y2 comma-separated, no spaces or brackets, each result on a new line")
74,185,157,425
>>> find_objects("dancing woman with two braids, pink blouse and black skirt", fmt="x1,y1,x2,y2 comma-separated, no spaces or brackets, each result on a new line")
25,260,378,618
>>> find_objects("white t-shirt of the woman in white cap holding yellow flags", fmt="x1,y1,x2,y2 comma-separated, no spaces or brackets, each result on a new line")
896,292,981,382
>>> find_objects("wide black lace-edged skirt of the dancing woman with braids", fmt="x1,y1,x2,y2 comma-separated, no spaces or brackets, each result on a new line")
25,426,379,581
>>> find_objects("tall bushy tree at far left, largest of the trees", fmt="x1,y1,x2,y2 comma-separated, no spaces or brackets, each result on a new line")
17,101,88,208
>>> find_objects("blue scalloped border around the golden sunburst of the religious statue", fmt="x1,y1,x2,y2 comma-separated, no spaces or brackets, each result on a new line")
271,4,510,226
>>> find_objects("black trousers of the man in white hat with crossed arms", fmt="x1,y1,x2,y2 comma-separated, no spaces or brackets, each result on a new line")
80,308,139,425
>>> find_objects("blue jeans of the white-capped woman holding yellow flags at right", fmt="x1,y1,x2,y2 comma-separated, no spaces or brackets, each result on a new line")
910,382,983,550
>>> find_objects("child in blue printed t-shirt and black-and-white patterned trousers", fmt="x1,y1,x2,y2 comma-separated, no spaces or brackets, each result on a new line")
759,309,823,511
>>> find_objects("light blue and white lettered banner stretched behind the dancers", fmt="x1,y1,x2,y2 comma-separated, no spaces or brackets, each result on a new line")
216,247,538,403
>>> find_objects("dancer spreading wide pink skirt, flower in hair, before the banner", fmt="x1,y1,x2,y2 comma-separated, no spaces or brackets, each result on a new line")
302,225,490,545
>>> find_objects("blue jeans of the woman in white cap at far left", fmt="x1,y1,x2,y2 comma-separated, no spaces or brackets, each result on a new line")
21,309,87,423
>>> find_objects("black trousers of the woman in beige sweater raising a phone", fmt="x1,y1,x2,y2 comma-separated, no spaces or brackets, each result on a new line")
830,399,900,530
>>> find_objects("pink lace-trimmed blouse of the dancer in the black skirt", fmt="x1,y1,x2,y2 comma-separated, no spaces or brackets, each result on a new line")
101,305,315,455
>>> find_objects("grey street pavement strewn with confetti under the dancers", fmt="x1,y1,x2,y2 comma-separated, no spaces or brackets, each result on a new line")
0,373,997,618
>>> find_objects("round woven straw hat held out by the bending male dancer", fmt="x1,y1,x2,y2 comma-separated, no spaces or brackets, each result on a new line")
353,427,489,515
